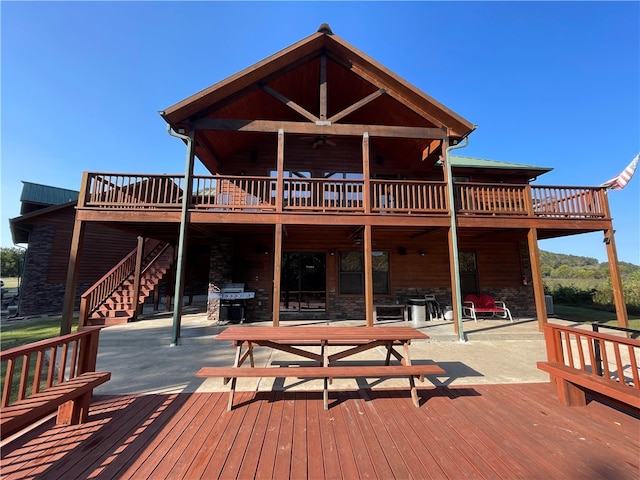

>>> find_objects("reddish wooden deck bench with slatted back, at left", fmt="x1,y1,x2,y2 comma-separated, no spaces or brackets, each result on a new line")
0,327,111,438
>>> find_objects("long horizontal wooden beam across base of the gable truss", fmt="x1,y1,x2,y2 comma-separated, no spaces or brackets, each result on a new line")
192,118,446,140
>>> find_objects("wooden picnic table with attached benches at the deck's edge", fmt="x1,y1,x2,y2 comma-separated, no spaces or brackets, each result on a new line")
196,327,445,410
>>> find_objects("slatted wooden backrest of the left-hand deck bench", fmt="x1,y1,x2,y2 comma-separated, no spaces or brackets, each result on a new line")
0,327,101,408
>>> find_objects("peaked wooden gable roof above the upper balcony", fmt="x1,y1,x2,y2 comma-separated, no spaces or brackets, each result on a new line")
160,25,475,143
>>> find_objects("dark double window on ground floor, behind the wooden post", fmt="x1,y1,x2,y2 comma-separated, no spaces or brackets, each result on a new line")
339,252,389,295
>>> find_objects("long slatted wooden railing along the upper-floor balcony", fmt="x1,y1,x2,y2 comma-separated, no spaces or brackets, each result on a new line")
83,173,607,218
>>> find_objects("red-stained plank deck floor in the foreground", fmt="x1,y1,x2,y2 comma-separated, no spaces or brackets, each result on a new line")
0,383,640,480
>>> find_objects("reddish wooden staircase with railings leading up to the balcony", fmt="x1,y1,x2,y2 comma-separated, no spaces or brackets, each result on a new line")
80,240,173,326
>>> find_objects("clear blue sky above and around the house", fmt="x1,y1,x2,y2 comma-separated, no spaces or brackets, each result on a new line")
0,1,640,264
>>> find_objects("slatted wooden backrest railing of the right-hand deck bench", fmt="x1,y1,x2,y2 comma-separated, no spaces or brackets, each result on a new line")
545,324,640,390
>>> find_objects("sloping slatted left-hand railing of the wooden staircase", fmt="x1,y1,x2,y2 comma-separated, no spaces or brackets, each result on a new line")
78,239,168,327
